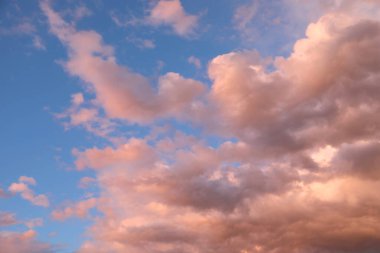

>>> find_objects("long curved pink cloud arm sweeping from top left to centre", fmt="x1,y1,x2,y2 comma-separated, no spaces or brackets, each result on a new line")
41,2,204,123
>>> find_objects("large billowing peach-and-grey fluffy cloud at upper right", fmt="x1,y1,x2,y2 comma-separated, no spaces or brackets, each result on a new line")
209,9,380,154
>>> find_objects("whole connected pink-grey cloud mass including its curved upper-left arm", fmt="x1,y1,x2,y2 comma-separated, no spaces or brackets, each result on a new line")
40,1,380,253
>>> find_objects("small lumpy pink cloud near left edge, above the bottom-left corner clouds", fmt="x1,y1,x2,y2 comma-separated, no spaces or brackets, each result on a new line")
8,176,49,207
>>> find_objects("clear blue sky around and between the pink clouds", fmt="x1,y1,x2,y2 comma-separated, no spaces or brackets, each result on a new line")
0,0,312,252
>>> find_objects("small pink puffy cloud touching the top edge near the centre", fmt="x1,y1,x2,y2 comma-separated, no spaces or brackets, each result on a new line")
147,0,198,36
